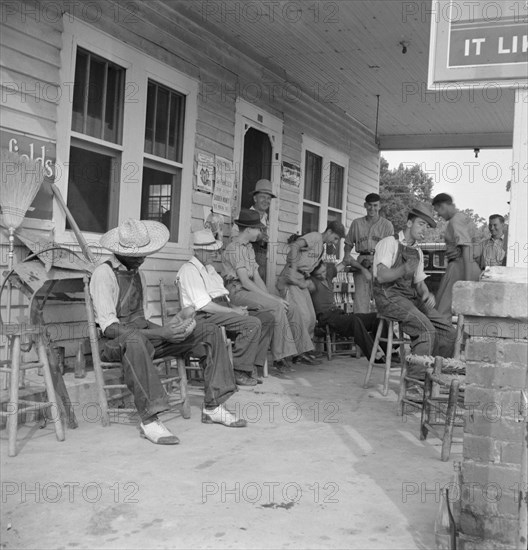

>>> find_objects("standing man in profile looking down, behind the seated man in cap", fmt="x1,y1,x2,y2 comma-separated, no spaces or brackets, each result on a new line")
433,193,481,320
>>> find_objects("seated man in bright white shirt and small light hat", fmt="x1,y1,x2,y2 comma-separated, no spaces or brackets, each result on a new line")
178,229,273,386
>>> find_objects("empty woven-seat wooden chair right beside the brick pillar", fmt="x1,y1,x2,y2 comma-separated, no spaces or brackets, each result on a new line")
420,357,466,462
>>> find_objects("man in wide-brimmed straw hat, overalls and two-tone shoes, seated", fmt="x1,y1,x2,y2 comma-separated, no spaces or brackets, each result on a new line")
90,219,246,445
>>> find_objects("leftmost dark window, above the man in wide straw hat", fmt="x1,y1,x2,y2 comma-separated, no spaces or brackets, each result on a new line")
66,48,125,233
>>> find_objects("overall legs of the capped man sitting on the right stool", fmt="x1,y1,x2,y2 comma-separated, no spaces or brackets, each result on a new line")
375,289,456,357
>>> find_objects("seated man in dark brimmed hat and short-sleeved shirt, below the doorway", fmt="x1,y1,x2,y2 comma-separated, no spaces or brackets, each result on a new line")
223,210,296,370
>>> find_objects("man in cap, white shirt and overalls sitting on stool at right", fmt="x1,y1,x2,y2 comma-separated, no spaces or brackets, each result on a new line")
373,203,456,376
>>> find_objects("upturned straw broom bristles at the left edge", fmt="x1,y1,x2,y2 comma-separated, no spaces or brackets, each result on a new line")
0,149,45,229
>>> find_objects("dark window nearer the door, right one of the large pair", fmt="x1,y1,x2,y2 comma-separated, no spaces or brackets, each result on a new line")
141,80,185,241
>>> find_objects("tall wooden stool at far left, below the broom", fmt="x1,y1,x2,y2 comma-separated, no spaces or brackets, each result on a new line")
0,325,64,456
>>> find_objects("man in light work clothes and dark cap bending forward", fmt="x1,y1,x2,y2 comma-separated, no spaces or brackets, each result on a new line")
277,221,345,365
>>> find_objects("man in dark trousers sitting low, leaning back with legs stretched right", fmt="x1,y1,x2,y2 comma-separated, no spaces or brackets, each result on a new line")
308,262,385,364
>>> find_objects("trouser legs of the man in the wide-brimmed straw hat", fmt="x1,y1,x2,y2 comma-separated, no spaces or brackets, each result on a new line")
100,320,237,420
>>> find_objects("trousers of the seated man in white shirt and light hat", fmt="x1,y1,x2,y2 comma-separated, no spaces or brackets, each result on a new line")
196,311,273,375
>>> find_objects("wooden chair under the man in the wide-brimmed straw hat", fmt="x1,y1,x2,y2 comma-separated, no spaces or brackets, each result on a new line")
84,277,191,426
